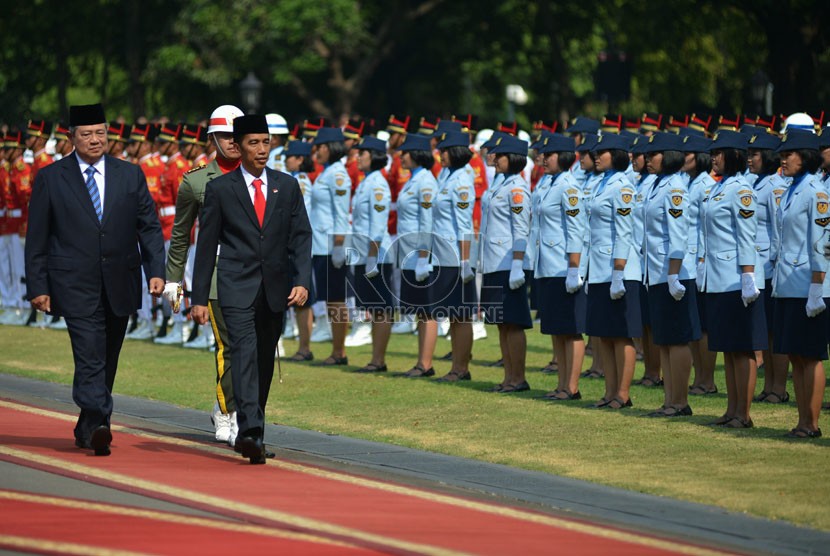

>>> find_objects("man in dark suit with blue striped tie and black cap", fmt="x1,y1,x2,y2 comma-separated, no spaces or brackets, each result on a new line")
26,104,164,455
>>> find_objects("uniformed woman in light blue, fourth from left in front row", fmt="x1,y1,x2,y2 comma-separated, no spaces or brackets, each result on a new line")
394,134,438,378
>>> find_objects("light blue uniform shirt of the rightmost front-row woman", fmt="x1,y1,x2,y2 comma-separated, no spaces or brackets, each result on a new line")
772,174,830,299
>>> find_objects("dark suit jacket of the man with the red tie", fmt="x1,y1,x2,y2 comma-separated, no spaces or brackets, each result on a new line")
191,168,311,312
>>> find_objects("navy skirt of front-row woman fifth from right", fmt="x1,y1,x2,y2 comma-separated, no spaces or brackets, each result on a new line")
533,278,588,336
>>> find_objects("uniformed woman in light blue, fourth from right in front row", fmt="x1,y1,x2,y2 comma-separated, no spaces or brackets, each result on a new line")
586,133,642,409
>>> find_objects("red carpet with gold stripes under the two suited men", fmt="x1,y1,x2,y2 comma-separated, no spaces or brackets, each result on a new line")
0,402,736,556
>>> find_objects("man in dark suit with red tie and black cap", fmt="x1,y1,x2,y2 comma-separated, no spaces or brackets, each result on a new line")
191,115,311,463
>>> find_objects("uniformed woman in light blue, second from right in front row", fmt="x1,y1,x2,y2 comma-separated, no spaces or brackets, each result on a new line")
698,131,767,428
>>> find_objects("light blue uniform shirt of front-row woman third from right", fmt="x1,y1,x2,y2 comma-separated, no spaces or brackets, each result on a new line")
643,174,691,286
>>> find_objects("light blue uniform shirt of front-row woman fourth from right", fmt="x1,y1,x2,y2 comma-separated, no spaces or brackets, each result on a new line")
586,171,641,284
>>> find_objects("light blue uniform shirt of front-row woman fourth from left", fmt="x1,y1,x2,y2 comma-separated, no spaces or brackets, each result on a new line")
393,167,438,270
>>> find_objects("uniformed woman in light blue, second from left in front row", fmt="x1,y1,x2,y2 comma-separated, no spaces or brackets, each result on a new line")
309,127,352,366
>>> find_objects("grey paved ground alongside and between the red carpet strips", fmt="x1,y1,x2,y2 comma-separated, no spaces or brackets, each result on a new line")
0,375,830,554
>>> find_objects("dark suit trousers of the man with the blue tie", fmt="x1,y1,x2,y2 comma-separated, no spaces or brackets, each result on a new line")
65,288,129,439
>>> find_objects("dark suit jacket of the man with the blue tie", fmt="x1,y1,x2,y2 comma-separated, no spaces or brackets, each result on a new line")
26,153,164,317
